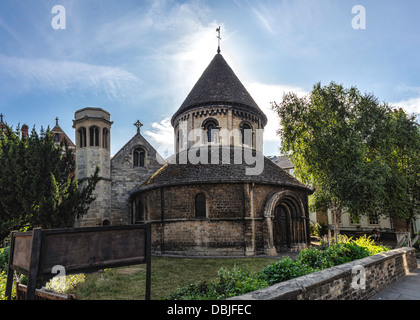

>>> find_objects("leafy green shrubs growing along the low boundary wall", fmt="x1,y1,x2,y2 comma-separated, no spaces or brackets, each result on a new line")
166,236,388,300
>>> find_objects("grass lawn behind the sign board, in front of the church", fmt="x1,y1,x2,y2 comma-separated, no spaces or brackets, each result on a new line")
72,257,275,300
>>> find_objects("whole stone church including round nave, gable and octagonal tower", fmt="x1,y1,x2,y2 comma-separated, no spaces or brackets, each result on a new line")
73,52,312,256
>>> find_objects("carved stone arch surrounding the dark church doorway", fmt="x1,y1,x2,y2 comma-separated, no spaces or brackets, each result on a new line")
264,190,308,255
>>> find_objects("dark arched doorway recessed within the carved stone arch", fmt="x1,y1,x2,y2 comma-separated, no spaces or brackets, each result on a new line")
273,204,291,252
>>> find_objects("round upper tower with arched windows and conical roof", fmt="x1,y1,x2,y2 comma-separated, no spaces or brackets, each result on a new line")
172,49,267,153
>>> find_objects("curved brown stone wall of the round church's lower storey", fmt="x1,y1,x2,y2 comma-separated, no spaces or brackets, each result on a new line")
135,183,305,256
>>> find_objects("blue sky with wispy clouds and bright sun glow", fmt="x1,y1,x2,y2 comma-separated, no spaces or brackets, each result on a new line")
0,0,420,158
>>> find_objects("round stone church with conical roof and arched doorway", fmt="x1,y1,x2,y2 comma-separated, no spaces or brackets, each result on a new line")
127,52,312,256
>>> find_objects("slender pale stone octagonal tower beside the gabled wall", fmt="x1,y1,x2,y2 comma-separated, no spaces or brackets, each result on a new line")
73,107,112,227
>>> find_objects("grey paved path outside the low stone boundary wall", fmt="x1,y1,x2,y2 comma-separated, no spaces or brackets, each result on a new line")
369,259,420,300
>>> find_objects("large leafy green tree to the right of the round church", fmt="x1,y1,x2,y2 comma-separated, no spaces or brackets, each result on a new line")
272,82,418,235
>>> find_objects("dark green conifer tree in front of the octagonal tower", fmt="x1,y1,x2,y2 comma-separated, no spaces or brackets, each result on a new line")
0,128,100,238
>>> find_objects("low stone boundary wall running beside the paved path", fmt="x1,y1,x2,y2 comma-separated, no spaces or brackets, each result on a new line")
232,247,417,300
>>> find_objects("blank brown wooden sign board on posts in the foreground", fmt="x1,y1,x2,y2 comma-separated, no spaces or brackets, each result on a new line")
6,224,151,299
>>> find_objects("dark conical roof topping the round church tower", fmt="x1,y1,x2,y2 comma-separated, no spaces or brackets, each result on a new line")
172,53,267,126
